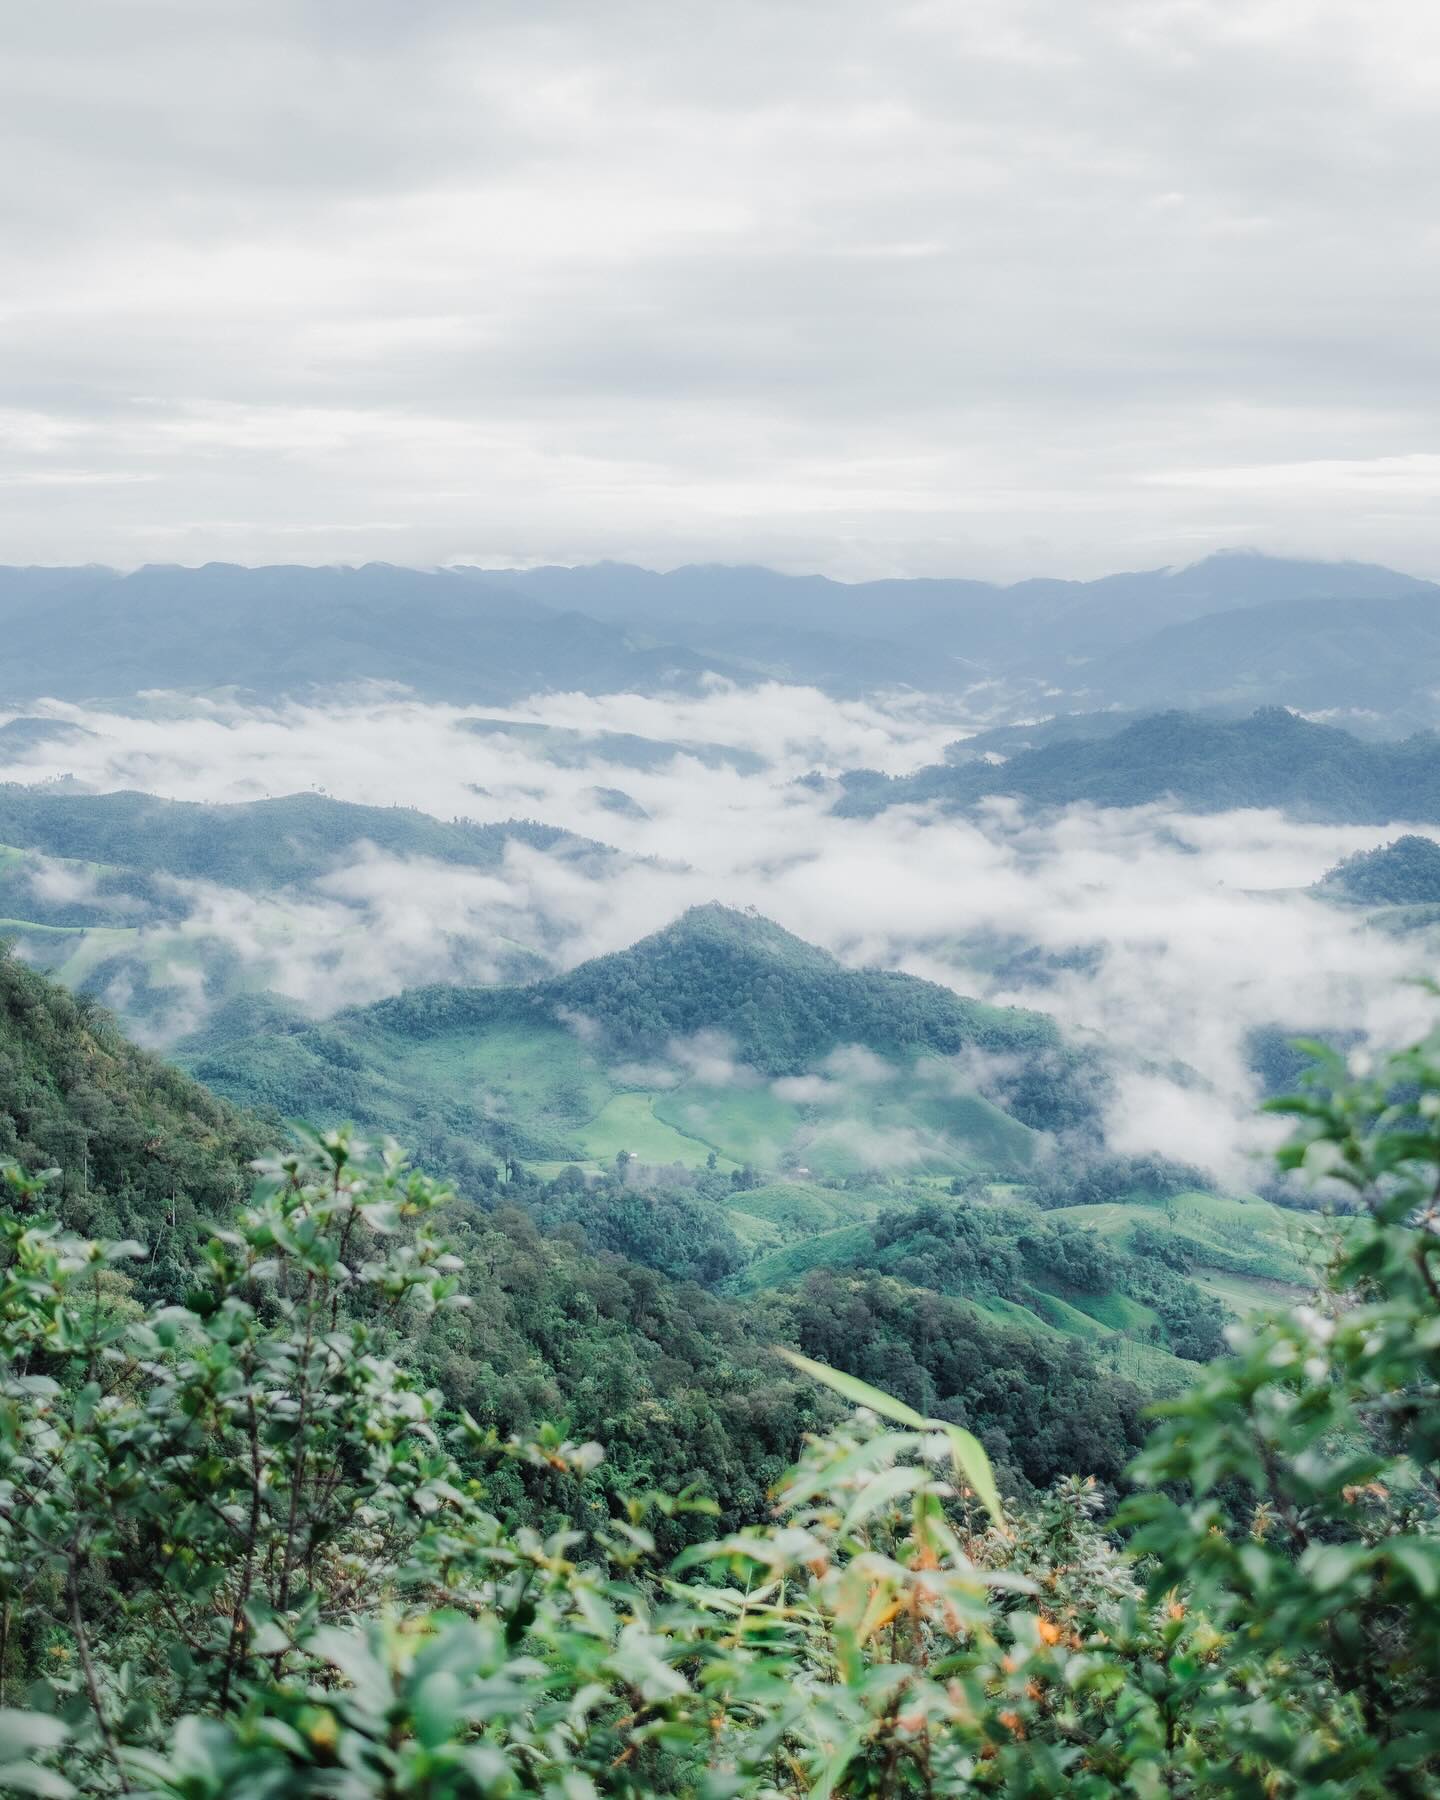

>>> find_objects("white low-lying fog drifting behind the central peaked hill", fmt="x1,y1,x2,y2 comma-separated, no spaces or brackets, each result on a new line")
0,686,1431,1179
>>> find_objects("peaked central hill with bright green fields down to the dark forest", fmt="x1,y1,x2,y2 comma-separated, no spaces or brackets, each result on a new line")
182,907,1314,1390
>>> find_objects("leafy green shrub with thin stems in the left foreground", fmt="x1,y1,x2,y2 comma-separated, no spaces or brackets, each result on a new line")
0,1134,496,1782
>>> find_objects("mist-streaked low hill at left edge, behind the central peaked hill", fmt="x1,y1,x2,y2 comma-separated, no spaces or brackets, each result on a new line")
0,783,625,1044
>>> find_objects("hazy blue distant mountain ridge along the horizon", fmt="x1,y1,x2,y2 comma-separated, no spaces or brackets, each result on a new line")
0,553,1440,722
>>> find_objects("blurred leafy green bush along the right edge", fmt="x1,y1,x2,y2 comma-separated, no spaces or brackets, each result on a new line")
1123,1035,1440,1796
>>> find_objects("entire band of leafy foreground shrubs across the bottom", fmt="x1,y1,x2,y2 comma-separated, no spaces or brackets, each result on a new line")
0,1042,1440,1800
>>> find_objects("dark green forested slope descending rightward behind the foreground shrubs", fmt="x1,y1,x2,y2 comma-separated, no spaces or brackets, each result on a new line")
0,958,1141,1519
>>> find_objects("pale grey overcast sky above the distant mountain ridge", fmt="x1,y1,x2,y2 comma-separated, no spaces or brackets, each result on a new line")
0,0,1440,578
